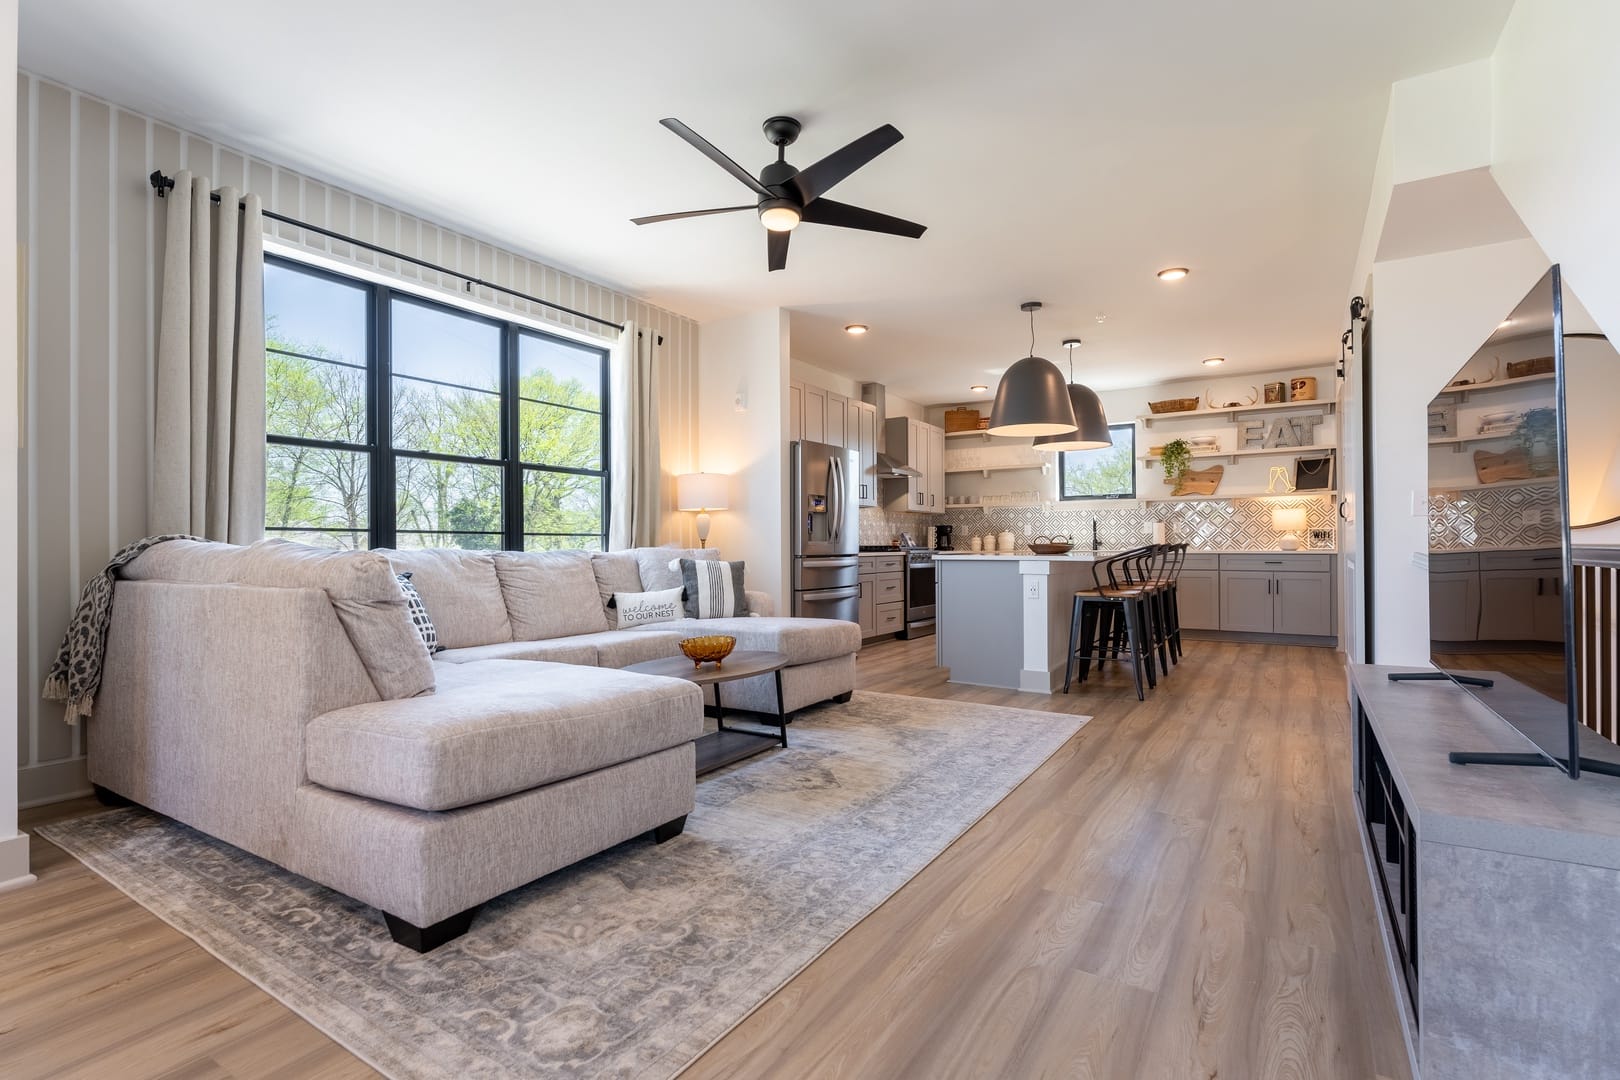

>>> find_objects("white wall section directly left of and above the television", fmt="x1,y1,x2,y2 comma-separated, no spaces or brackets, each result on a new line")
1369,240,1547,664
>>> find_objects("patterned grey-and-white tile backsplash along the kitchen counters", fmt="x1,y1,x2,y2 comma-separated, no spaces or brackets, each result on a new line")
860,495,1338,551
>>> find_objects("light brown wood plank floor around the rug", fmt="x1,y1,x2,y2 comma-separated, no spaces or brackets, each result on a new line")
0,638,1409,1080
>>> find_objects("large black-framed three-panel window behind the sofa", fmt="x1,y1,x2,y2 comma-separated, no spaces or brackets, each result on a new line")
264,256,609,551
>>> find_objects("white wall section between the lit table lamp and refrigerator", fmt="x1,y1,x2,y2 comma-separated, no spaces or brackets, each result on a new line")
698,308,791,614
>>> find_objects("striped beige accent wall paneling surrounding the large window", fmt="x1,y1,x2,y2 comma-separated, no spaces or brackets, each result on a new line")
18,73,698,806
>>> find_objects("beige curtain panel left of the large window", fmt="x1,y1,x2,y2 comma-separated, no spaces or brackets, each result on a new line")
146,172,264,544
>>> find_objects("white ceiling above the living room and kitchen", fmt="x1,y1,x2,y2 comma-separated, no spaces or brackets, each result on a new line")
21,0,1511,402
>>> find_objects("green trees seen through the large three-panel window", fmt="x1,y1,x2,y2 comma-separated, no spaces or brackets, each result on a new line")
264,314,603,549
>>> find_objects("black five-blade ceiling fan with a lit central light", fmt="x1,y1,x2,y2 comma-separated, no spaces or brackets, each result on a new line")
630,117,928,270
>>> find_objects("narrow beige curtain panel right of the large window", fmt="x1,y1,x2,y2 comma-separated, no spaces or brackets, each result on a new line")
608,322,664,551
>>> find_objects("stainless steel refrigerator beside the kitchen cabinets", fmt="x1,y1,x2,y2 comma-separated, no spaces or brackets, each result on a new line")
789,442,860,622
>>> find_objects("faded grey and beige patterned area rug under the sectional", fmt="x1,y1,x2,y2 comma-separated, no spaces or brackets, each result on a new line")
39,693,1089,1080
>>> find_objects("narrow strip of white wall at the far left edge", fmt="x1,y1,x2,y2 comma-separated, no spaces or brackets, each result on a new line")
0,0,32,889
